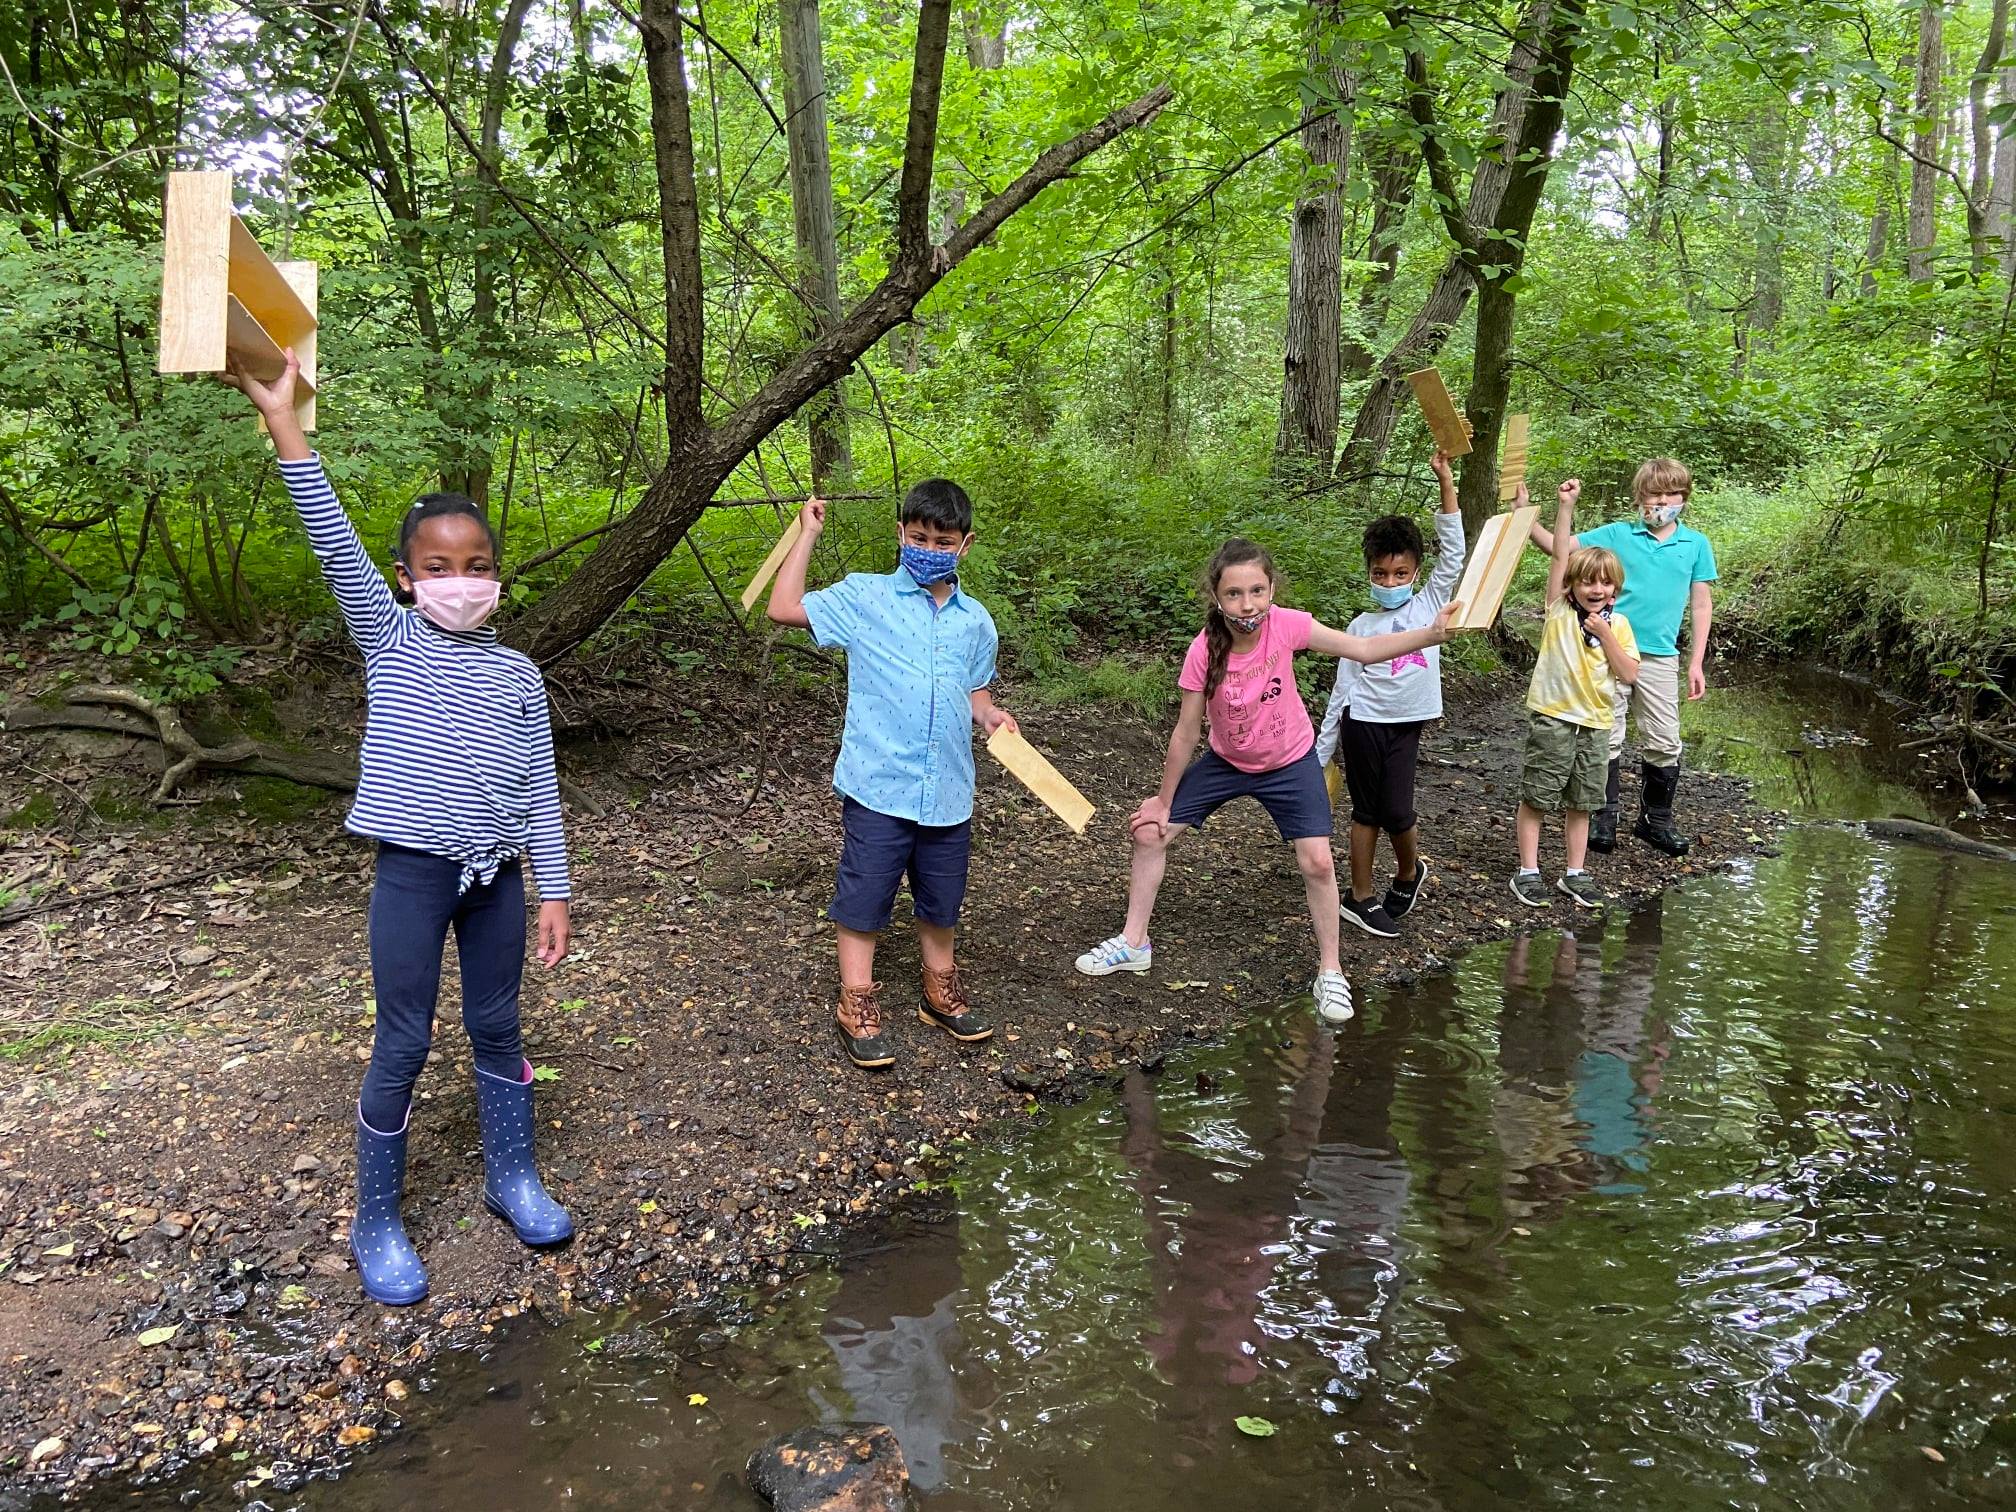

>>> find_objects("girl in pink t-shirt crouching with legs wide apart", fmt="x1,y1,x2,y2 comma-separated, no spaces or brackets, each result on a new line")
1079,540,1460,1024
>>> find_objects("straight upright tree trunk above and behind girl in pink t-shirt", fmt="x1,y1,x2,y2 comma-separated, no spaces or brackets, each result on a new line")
1274,0,1357,470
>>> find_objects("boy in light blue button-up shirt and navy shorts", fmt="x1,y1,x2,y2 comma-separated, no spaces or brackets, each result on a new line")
770,478,1016,1066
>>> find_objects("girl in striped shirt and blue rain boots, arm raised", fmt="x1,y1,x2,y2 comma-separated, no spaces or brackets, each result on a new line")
232,351,575,1304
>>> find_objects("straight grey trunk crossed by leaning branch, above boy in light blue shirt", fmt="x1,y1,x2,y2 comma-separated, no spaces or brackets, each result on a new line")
778,0,855,492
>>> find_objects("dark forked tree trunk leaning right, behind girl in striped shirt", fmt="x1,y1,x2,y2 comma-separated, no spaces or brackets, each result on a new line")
508,60,1171,663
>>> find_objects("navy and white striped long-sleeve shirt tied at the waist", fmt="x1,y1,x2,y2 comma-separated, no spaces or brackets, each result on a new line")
280,456,571,903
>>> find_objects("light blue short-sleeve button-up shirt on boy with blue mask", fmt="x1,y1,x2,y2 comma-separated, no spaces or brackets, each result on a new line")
804,566,1000,825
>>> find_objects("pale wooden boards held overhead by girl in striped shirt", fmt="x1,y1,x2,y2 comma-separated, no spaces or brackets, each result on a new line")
155,171,317,431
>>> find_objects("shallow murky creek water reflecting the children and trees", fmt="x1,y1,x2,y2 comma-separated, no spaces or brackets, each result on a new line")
106,669,2016,1512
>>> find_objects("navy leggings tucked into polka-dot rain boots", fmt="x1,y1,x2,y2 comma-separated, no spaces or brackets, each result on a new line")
357,845,524,1133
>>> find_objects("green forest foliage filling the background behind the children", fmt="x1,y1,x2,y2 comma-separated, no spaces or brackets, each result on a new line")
0,0,2016,710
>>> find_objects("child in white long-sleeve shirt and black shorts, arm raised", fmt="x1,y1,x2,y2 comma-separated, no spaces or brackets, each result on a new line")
1316,452,1464,939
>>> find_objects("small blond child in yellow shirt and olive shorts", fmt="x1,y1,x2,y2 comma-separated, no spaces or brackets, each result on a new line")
1512,478,1637,909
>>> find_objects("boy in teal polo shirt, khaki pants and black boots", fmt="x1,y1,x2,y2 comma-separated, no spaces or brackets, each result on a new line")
1532,458,1716,857
